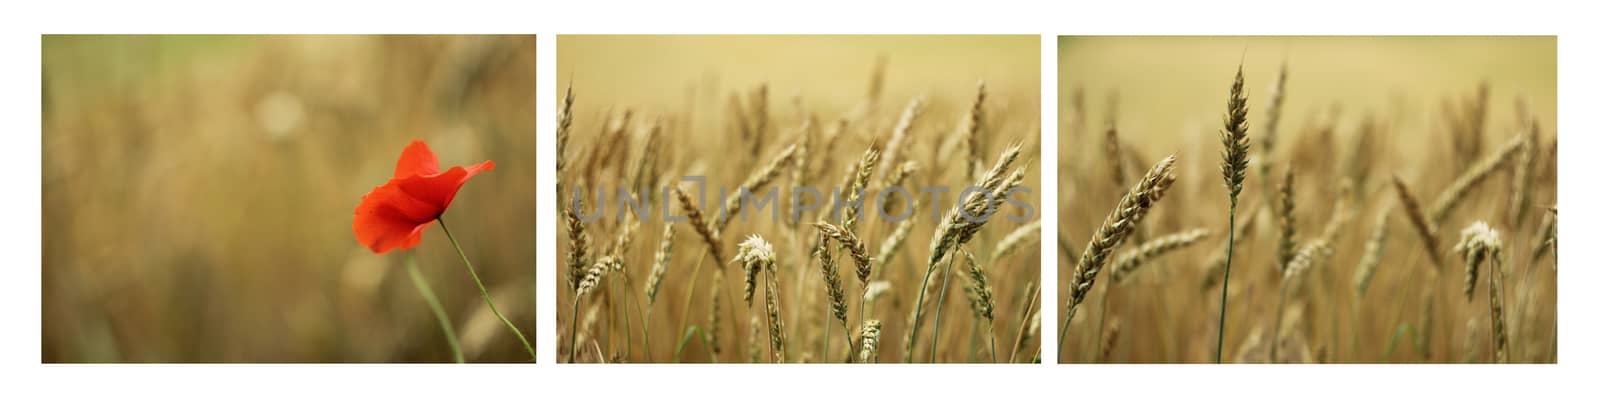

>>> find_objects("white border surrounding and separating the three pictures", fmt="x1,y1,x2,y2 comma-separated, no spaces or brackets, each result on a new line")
0,0,1600,397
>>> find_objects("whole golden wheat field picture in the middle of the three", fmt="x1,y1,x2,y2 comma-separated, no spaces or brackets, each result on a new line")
557,35,1040,362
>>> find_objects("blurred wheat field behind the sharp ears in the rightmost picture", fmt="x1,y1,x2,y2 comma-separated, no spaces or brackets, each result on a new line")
1056,37,1557,362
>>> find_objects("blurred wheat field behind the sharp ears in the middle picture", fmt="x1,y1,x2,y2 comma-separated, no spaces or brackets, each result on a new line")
546,35,1040,362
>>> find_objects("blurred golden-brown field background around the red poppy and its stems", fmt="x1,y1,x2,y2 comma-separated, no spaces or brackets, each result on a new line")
42,35,534,362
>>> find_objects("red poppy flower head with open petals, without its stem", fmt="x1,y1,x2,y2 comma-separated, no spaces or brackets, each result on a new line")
352,139,494,253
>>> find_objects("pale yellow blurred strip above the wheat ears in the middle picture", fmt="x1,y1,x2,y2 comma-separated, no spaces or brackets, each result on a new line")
555,35,1040,118
